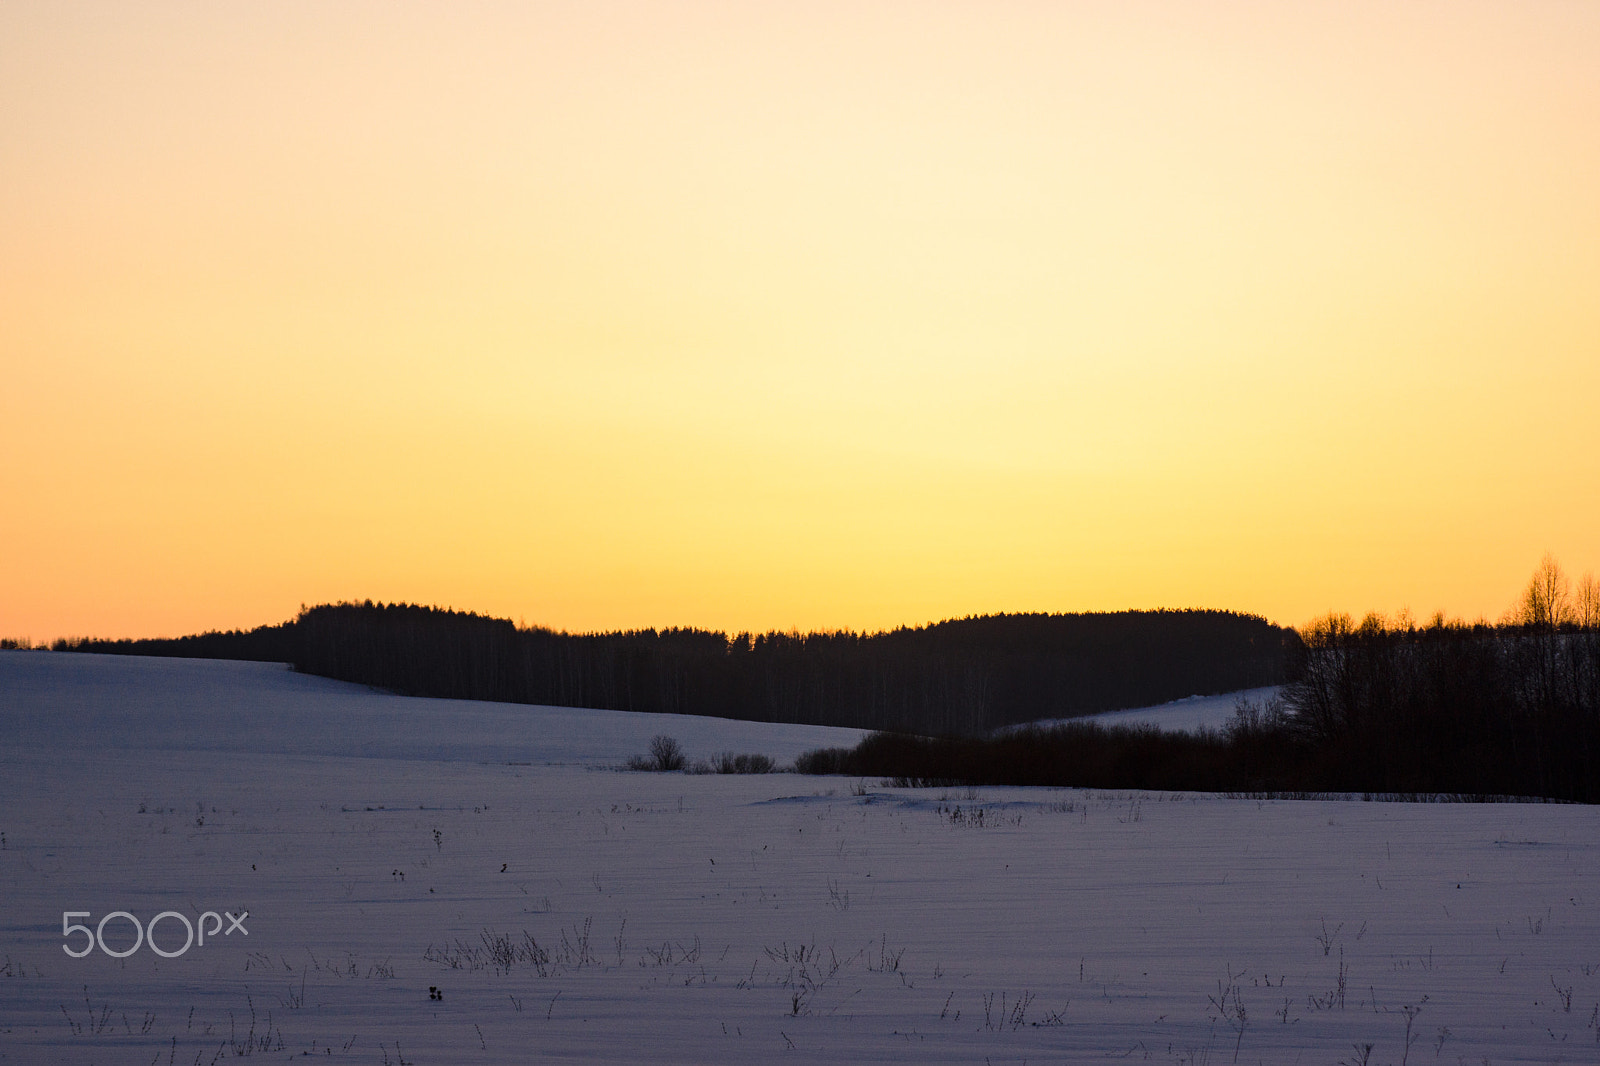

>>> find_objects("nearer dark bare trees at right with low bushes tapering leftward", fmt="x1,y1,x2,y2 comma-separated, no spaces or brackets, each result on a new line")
812,559,1600,804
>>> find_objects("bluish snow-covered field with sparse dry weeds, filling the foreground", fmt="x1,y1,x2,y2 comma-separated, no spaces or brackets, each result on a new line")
0,653,1600,1066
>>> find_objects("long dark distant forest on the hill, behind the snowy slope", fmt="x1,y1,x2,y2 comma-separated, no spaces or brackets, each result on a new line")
58,602,1298,735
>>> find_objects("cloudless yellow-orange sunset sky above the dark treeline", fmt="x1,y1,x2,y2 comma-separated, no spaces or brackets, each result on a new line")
0,0,1600,640
